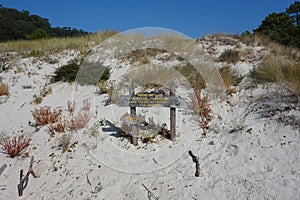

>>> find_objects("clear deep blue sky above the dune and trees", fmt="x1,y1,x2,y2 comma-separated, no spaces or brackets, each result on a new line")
0,0,295,38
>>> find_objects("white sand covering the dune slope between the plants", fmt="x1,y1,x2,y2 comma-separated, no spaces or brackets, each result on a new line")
0,36,300,200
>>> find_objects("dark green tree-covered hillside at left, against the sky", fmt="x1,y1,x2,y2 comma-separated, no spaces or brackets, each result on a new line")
0,5,88,42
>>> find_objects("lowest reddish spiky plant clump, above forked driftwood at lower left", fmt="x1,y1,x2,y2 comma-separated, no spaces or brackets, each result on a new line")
1,136,30,158
